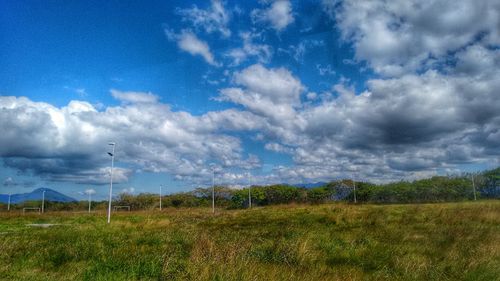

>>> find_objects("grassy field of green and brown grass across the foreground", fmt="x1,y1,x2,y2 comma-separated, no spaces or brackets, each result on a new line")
0,201,500,281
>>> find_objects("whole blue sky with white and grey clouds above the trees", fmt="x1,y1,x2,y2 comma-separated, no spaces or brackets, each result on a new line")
0,0,500,199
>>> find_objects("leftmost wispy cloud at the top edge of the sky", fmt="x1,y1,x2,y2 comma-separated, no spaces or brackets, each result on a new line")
177,0,231,37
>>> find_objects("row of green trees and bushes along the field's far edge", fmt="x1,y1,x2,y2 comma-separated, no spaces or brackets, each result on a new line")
0,168,500,211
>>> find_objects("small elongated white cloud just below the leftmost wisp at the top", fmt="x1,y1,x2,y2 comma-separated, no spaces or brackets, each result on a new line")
165,29,219,66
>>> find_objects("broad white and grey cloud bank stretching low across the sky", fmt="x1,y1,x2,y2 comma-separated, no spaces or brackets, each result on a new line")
4,56,500,184
